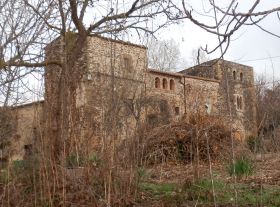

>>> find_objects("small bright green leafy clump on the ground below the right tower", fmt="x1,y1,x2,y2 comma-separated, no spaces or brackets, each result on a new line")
228,156,254,178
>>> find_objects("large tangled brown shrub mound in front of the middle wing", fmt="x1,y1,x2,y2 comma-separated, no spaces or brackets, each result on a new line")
138,115,248,164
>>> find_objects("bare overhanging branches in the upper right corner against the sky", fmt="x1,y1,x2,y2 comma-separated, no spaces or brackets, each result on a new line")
182,0,280,57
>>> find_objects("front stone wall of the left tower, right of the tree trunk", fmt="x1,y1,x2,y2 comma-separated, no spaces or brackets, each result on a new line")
77,36,147,149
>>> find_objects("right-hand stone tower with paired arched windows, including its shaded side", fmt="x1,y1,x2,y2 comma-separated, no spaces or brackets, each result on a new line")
181,60,256,139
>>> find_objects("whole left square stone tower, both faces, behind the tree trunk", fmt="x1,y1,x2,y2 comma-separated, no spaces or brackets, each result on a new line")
44,35,147,152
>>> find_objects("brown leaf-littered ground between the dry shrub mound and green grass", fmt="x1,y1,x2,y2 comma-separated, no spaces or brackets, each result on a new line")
147,153,280,185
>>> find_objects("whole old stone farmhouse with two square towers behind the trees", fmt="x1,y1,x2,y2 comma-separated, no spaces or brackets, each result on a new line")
6,36,256,159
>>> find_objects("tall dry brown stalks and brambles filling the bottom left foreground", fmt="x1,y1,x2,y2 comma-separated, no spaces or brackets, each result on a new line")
0,152,137,207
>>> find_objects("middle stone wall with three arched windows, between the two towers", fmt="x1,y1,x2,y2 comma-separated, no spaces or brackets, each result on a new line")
146,70,219,123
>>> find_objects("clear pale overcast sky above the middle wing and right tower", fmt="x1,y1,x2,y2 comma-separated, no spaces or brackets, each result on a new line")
158,0,280,79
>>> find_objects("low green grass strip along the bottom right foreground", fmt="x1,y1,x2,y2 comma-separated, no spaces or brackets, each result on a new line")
139,179,280,207
